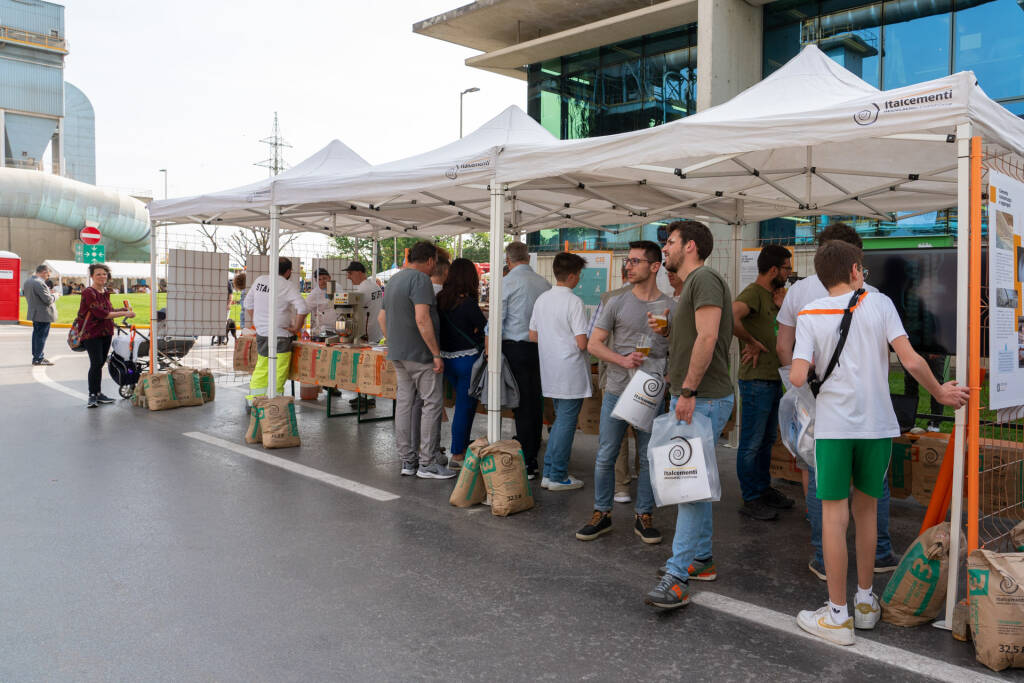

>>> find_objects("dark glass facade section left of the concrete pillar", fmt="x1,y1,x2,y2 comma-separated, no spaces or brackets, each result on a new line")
526,24,697,251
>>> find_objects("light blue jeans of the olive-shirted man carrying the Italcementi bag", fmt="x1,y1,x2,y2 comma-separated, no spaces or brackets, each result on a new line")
667,394,735,581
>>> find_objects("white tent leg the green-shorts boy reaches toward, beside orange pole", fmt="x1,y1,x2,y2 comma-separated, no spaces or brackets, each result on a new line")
935,123,971,630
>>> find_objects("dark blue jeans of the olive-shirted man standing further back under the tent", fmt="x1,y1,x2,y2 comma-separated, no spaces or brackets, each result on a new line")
736,380,782,501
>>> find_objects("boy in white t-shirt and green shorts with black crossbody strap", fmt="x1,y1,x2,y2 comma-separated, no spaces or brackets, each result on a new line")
790,241,969,645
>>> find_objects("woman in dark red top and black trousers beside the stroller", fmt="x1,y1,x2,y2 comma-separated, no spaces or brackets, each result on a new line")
75,263,135,408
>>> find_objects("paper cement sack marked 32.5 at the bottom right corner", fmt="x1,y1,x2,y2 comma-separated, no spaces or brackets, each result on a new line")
967,550,1024,671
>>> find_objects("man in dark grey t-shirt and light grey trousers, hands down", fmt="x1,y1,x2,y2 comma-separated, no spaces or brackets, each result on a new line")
378,242,455,479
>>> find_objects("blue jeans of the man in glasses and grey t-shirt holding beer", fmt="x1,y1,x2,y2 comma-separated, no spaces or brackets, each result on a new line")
594,392,654,515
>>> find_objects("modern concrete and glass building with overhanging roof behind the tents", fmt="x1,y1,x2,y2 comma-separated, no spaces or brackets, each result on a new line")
413,0,1024,251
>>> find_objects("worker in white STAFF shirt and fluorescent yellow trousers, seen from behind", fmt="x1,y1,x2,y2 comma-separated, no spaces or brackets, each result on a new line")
245,256,308,403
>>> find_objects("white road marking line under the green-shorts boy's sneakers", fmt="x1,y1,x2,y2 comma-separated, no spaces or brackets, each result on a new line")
690,591,1005,683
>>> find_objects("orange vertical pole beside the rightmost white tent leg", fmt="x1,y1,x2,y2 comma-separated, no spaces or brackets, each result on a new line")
967,136,981,552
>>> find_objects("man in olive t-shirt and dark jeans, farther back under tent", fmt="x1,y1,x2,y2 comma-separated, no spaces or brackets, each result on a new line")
732,245,794,521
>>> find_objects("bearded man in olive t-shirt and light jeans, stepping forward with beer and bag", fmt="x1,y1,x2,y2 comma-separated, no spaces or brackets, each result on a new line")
644,220,734,609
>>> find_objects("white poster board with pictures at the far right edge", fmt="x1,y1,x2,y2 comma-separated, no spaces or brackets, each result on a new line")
988,171,1024,411
